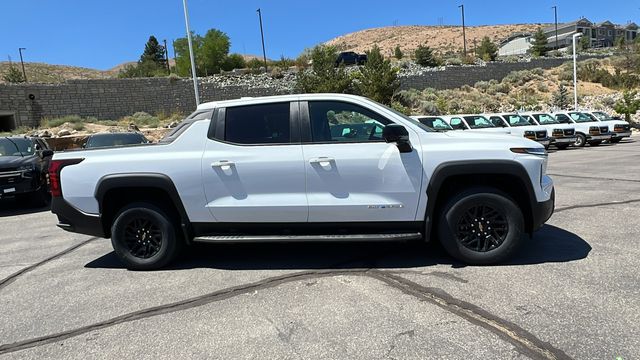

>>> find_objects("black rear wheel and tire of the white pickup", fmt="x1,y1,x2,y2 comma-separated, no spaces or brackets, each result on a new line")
111,203,183,270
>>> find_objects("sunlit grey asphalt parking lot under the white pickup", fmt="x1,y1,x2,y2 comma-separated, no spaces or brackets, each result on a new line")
0,133,640,359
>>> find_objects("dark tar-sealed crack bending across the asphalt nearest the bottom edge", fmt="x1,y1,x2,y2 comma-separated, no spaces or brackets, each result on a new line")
0,269,570,359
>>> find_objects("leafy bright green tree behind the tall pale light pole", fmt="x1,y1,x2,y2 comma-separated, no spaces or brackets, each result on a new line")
174,29,231,76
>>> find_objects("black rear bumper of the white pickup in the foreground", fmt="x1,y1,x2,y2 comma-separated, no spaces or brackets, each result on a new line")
51,198,107,237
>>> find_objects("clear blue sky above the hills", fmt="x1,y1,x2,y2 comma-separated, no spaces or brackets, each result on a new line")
0,0,640,70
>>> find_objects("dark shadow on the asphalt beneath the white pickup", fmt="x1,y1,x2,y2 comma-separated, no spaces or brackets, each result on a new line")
85,225,591,270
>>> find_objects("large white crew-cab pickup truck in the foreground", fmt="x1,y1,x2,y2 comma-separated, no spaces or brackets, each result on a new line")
49,94,554,269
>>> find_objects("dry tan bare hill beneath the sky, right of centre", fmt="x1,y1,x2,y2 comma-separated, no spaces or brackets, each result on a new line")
326,24,546,56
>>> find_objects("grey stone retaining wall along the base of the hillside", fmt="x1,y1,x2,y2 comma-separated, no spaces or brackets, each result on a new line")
0,59,600,130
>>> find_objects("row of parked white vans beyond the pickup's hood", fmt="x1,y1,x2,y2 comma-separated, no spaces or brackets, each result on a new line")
412,111,631,150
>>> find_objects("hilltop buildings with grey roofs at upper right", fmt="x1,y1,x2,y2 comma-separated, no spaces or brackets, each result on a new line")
498,18,639,56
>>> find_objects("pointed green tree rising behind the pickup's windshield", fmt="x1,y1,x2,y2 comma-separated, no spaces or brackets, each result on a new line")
356,45,400,105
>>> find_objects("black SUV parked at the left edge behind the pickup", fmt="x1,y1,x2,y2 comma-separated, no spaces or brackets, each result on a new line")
0,137,53,206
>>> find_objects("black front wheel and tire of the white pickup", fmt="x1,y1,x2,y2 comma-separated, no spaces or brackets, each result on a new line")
438,188,524,265
